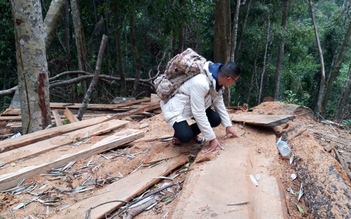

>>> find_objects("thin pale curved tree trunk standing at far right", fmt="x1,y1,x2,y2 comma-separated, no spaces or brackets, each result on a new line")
309,0,325,115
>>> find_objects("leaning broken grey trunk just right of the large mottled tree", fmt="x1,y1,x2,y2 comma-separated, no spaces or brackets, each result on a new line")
77,35,107,120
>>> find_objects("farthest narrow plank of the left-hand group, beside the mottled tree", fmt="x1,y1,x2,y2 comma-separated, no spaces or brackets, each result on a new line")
0,116,111,153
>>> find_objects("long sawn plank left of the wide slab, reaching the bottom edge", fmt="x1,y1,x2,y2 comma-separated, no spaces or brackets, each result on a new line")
51,155,188,219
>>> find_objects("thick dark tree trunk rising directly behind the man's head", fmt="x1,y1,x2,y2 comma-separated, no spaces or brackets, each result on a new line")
213,0,231,106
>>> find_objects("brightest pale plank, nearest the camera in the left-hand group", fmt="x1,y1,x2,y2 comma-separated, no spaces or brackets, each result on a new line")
0,130,144,191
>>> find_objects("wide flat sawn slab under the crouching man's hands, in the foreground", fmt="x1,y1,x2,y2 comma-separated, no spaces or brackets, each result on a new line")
167,138,287,219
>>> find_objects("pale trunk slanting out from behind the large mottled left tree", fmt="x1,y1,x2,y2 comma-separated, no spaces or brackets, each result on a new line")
44,0,67,50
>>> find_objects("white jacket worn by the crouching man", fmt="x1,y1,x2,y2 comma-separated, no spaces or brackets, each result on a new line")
160,62,232,141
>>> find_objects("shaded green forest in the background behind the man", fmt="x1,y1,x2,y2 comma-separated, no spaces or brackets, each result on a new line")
0,0,351,126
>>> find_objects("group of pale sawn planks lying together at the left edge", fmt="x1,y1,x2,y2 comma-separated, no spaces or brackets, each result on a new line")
0,116,144,191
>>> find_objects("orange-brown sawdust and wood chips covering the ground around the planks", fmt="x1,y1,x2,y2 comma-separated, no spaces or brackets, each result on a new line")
0,102,351,219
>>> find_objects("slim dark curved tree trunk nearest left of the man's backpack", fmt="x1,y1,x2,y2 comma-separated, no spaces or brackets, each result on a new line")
129,10,141,97
